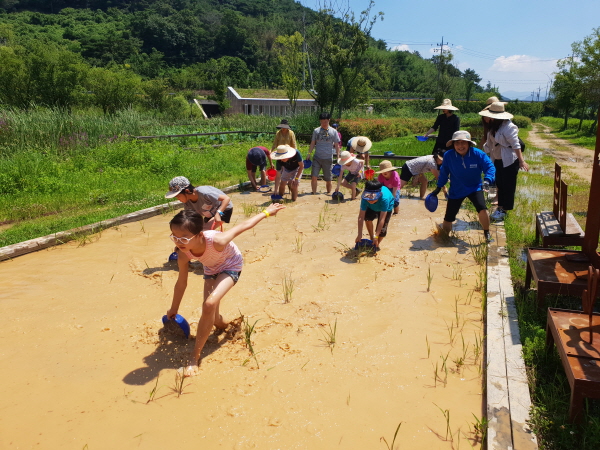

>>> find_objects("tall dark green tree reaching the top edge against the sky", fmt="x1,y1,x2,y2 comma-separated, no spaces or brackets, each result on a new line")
307,0,383,116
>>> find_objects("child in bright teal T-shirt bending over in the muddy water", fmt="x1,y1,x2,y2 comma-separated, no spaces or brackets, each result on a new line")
356,181,394,247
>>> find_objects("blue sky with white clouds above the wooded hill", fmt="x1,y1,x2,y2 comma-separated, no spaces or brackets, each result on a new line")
300,0,600,98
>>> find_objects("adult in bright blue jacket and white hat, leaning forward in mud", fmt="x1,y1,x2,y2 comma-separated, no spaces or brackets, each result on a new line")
432,131,496,242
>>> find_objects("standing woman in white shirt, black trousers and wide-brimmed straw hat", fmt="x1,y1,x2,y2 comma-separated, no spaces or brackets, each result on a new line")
479,102,529,220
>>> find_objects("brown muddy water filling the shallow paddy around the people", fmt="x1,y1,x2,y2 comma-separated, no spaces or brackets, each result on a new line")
0,182,483,450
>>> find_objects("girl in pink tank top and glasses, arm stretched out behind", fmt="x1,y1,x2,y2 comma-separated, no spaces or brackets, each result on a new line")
167,203,285,376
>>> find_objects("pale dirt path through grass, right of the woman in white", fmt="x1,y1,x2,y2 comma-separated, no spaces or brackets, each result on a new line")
525,123,594,182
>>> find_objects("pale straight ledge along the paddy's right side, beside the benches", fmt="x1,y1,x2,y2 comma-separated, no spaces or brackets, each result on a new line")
486,226,538,450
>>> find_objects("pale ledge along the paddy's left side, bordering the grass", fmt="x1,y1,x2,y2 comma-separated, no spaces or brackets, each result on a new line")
0,181,250,261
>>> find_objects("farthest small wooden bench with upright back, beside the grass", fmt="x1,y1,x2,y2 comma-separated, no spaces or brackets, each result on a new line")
535,163,585,247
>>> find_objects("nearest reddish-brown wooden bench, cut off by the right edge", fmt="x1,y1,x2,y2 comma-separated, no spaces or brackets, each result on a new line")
546,266,600,422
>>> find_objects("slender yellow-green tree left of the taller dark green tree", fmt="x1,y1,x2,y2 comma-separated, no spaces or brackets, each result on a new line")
275,31,306,114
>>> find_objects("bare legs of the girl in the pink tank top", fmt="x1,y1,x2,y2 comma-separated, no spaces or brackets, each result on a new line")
185,273,234,376
